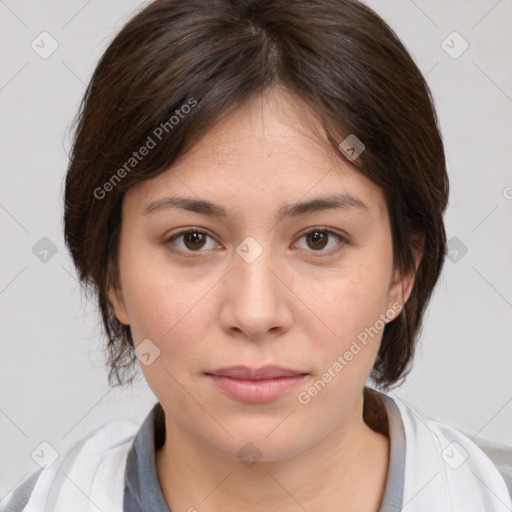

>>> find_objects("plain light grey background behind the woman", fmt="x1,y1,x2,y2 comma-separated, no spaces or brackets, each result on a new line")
0,0,512,498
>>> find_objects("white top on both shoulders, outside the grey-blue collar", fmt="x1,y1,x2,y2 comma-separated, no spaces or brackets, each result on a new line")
0,393,512,512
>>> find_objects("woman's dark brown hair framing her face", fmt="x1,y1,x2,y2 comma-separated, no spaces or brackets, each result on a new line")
64,0,448,388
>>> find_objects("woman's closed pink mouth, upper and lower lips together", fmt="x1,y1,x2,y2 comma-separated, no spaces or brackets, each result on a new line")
206,366,307,403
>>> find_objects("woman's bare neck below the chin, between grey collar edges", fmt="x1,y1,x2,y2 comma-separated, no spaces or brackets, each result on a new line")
156,393,389,512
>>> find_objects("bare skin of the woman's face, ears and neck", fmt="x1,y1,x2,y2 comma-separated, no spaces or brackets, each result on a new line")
108,89,413,512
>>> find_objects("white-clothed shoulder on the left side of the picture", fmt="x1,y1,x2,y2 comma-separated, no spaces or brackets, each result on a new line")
0,420,139,512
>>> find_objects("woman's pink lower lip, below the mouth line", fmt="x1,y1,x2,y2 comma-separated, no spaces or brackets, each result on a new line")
208,375,305,404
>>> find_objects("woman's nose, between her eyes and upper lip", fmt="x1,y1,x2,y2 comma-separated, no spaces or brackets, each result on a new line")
221,243,294,340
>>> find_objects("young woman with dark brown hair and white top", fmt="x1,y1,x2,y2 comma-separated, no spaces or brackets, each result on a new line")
2,0,512,512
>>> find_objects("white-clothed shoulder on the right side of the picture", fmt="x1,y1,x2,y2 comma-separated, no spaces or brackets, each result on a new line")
378,396,512,511
